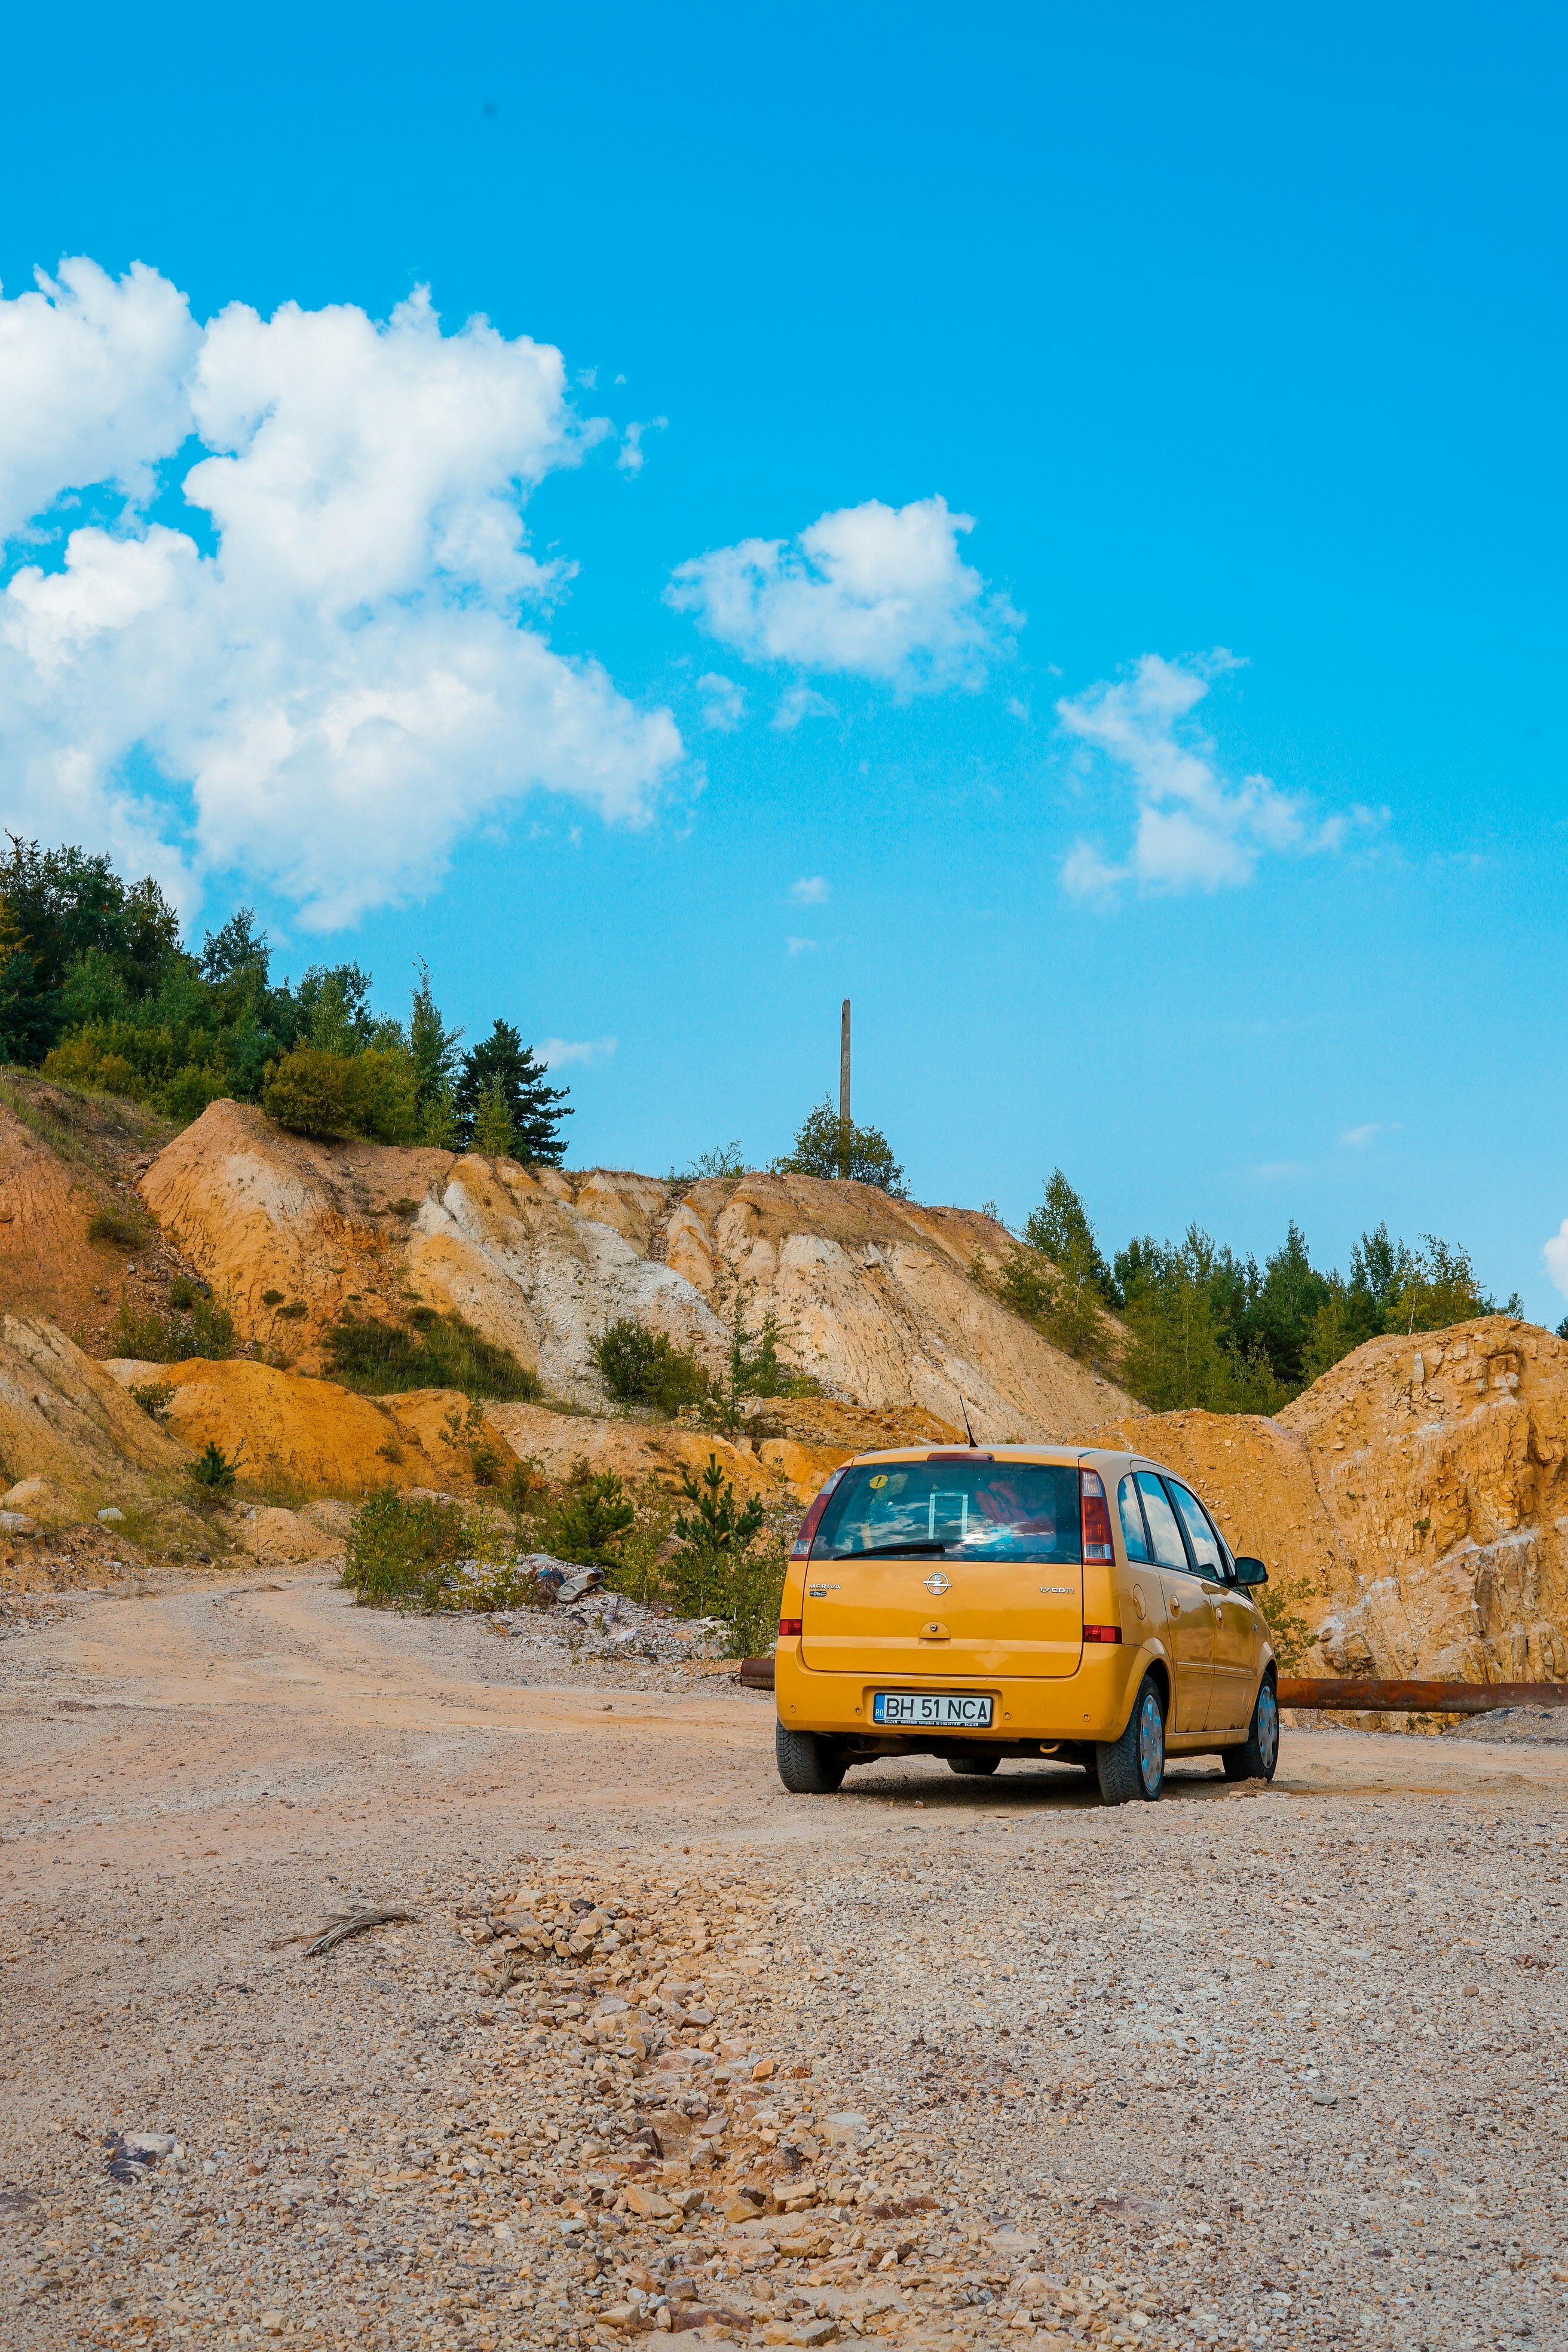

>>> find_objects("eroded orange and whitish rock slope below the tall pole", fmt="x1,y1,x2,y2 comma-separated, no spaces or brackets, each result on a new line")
141,1103,1135,1440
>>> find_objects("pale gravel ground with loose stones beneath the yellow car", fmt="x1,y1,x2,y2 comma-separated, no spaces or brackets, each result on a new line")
0,1571,1568,2352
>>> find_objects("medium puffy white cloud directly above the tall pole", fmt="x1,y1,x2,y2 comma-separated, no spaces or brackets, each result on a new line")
665,498,1020,694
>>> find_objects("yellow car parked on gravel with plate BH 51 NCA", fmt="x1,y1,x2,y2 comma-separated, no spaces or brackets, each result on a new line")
773,1447,1279,1804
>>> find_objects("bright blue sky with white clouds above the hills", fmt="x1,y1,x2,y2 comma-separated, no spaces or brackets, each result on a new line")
0,5,1568,1322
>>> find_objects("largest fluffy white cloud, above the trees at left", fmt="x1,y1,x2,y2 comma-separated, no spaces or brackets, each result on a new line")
0,261,682,924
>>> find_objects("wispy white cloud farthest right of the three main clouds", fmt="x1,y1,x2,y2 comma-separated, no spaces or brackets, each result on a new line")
1055,647,1373,899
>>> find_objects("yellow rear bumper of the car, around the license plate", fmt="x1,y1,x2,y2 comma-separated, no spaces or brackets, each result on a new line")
773,1642,1166,1754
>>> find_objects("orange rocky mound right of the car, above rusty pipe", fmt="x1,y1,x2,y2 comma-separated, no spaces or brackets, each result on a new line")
1105,1315,1568,1682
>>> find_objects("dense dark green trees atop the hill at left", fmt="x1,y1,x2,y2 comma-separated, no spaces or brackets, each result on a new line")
0,835,571,1166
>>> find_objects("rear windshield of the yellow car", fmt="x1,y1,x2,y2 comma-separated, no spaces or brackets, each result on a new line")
811,1460,1084,1560
